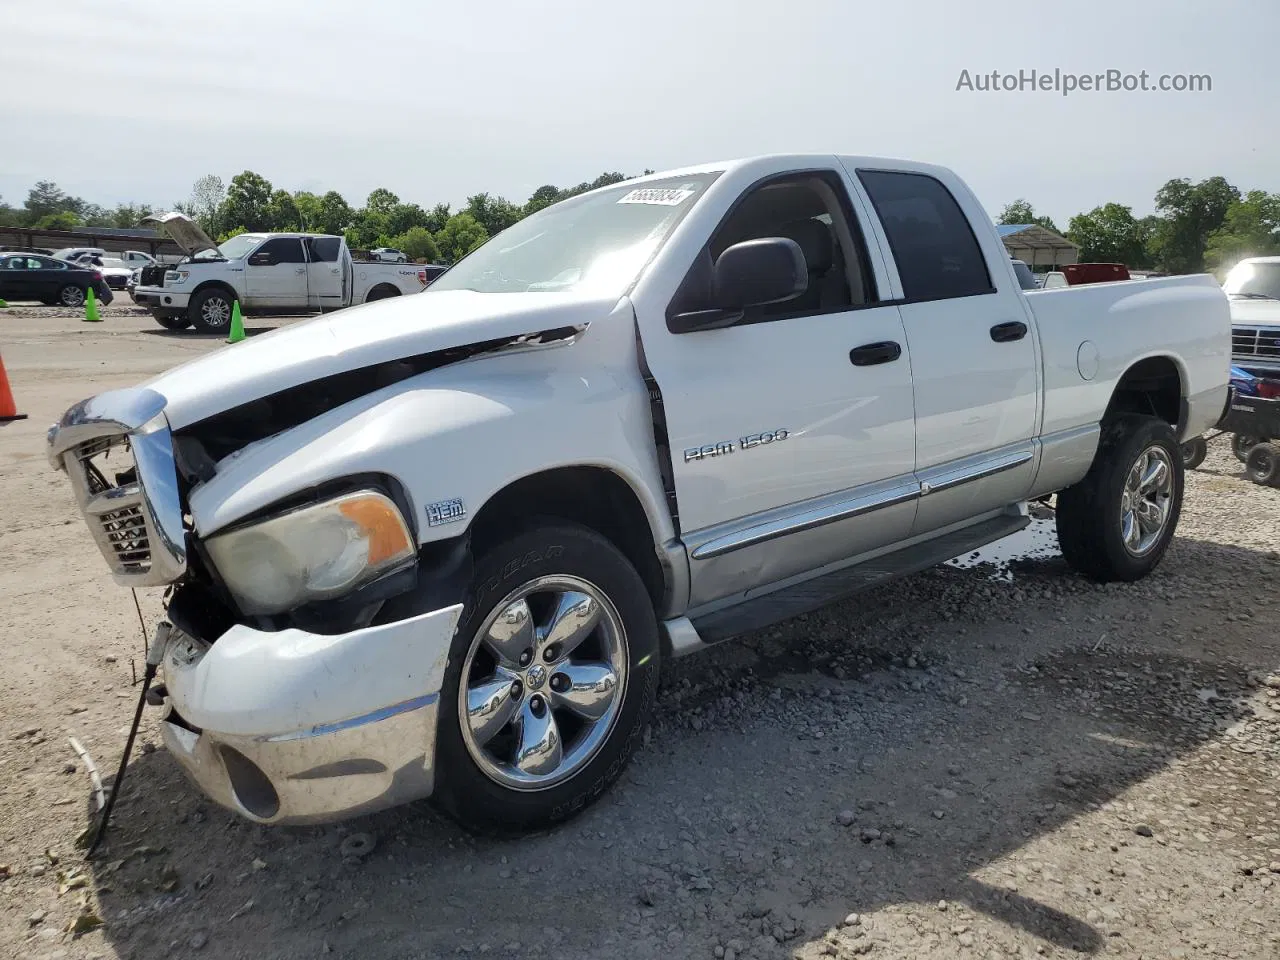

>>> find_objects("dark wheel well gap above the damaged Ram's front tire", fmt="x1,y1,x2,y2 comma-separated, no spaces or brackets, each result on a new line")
471,467,667,608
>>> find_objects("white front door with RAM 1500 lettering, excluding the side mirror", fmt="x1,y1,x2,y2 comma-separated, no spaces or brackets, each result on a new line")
636,169,919,609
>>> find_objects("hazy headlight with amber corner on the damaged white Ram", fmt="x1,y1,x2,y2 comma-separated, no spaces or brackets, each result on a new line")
205,490,416,616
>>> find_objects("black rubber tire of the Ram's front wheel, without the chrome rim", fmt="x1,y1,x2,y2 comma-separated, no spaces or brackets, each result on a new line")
431,518,660,836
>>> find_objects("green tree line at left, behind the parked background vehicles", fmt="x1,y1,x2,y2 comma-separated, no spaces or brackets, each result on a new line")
0,170,653,264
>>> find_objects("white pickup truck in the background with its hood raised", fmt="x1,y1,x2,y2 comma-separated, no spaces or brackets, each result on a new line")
131,212,439,333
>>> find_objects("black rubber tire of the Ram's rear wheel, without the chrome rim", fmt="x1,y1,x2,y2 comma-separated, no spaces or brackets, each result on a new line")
1057,415,1184,582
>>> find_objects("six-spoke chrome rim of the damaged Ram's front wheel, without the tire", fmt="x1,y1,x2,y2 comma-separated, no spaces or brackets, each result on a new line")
458,575,628,791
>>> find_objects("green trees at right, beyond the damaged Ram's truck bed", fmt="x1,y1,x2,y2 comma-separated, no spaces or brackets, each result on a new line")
997,177,1280,274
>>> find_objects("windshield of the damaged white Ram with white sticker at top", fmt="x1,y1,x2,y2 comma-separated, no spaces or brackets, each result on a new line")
426,174,716,297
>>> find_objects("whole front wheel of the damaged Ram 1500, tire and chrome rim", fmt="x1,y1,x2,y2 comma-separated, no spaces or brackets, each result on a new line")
434,520,660,835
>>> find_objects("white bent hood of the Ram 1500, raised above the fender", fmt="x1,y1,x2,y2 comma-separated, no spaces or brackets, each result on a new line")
145,289,617,430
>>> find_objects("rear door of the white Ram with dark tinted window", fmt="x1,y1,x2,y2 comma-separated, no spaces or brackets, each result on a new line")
858,169,1041,534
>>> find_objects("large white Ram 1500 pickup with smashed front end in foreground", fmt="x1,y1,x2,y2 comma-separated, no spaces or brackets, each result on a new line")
49,155,1230,832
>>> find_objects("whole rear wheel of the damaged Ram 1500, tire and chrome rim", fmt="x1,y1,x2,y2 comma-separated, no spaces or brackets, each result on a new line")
1057,415,1184,582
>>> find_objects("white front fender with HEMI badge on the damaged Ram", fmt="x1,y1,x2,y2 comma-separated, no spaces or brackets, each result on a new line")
191,300,675,544
